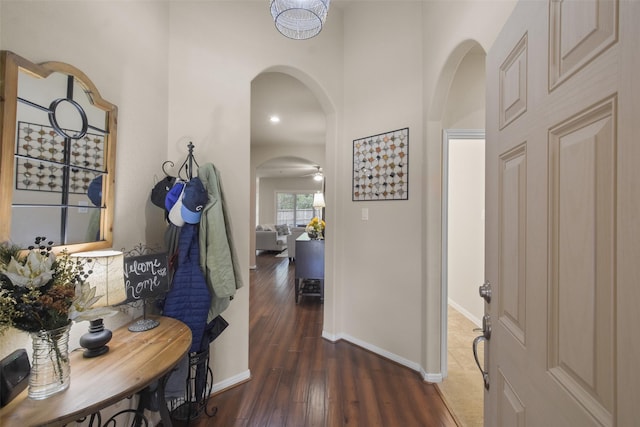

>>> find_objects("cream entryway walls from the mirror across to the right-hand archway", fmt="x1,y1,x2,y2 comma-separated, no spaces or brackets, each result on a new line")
0,0,511,396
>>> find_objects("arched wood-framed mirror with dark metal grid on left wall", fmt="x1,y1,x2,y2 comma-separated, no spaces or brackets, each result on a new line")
0,51,118,252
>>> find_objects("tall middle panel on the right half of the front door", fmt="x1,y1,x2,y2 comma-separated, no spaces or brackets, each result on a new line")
549,99,617,425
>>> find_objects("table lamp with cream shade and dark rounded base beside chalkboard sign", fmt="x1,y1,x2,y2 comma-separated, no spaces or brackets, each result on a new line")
72,250,127,357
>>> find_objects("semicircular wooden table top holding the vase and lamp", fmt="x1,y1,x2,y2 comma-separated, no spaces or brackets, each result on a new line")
0,317,191,427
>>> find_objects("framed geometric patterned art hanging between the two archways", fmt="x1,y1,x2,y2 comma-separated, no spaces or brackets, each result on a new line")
352,128,409,202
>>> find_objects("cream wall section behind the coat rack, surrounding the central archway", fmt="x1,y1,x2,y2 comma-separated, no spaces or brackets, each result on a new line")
168,1,342,388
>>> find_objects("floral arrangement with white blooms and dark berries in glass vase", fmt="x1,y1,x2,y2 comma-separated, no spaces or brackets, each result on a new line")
0,237,116,333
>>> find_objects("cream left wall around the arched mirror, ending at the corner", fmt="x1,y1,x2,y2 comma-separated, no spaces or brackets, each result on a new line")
0,0,169,366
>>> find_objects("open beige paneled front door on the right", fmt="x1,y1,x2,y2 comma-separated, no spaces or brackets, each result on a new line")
483,0,640,427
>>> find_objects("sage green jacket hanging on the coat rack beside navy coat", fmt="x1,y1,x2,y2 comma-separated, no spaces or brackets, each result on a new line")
198,163,242,323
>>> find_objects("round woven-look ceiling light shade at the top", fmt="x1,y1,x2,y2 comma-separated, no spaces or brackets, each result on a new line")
271,0,331,40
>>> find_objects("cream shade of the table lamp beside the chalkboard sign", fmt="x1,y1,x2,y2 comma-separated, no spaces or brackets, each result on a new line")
71,250,127,307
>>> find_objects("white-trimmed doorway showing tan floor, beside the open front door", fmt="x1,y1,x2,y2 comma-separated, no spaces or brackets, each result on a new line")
439,130,485,427
